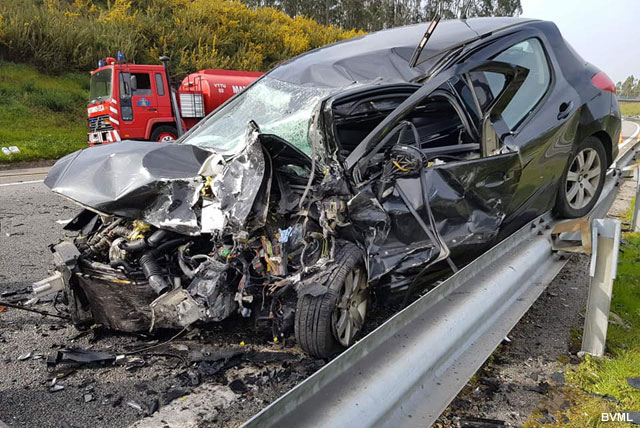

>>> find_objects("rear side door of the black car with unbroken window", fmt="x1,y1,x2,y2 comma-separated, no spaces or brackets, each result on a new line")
467,34,580,234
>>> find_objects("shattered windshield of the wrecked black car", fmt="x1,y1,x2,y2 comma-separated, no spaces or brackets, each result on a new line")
184,76,335,155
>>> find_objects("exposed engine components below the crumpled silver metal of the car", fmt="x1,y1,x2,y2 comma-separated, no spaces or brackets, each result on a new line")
54,202,345,337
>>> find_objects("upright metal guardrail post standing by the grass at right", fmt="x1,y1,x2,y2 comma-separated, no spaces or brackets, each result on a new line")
580,219,620,357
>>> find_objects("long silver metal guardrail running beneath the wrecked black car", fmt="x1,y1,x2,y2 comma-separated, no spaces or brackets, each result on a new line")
242,140,633,428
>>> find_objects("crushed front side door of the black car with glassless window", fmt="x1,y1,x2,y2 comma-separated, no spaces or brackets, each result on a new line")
347,76,522,287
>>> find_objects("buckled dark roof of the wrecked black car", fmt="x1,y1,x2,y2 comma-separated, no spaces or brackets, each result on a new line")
269,17,533,87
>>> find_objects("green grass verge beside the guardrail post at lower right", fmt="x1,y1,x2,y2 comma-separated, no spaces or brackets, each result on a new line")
524,202,640,428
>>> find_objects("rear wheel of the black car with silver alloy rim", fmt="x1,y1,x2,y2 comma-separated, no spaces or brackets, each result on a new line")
555,137,607,218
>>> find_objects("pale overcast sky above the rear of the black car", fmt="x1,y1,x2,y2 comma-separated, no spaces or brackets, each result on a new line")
521,0,640,83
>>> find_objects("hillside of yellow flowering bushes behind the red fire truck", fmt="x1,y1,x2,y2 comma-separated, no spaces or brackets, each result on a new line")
0,0,360,74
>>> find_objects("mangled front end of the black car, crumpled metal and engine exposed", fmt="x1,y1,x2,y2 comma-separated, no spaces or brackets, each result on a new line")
43,133,366,355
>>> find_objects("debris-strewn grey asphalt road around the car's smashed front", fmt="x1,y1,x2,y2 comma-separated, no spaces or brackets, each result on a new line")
0,179,323,428
